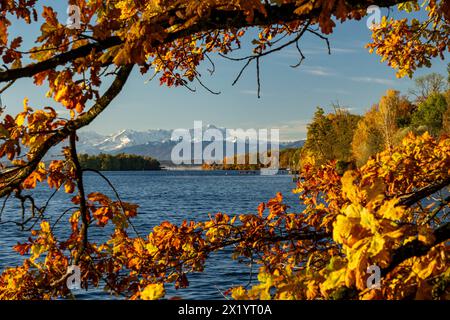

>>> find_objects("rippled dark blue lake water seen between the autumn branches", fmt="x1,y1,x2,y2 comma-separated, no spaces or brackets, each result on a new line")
0,171,301,299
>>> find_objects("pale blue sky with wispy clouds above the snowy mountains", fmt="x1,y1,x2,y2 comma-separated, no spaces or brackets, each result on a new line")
2,0,448,140
